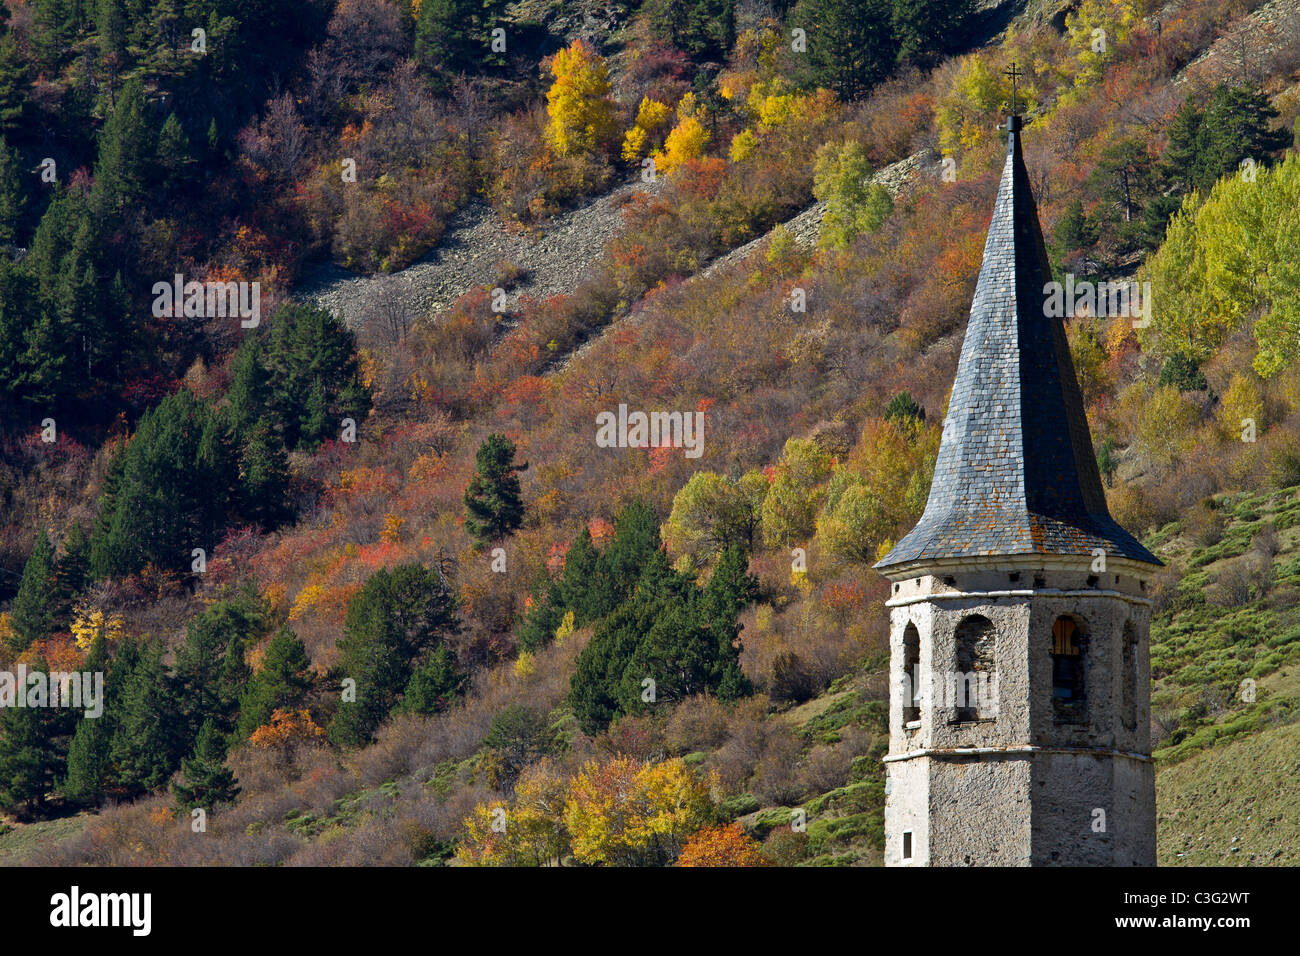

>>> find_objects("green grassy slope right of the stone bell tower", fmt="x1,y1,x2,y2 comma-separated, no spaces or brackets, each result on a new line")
1152,488,1300,866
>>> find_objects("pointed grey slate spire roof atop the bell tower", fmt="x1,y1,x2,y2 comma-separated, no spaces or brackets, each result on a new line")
876,116,1161,570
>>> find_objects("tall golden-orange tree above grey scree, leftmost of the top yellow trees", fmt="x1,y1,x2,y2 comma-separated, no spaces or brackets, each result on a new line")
546,39,619,156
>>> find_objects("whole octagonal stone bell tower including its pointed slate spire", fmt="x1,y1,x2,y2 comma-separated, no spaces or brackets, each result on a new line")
876,114,1160,866
